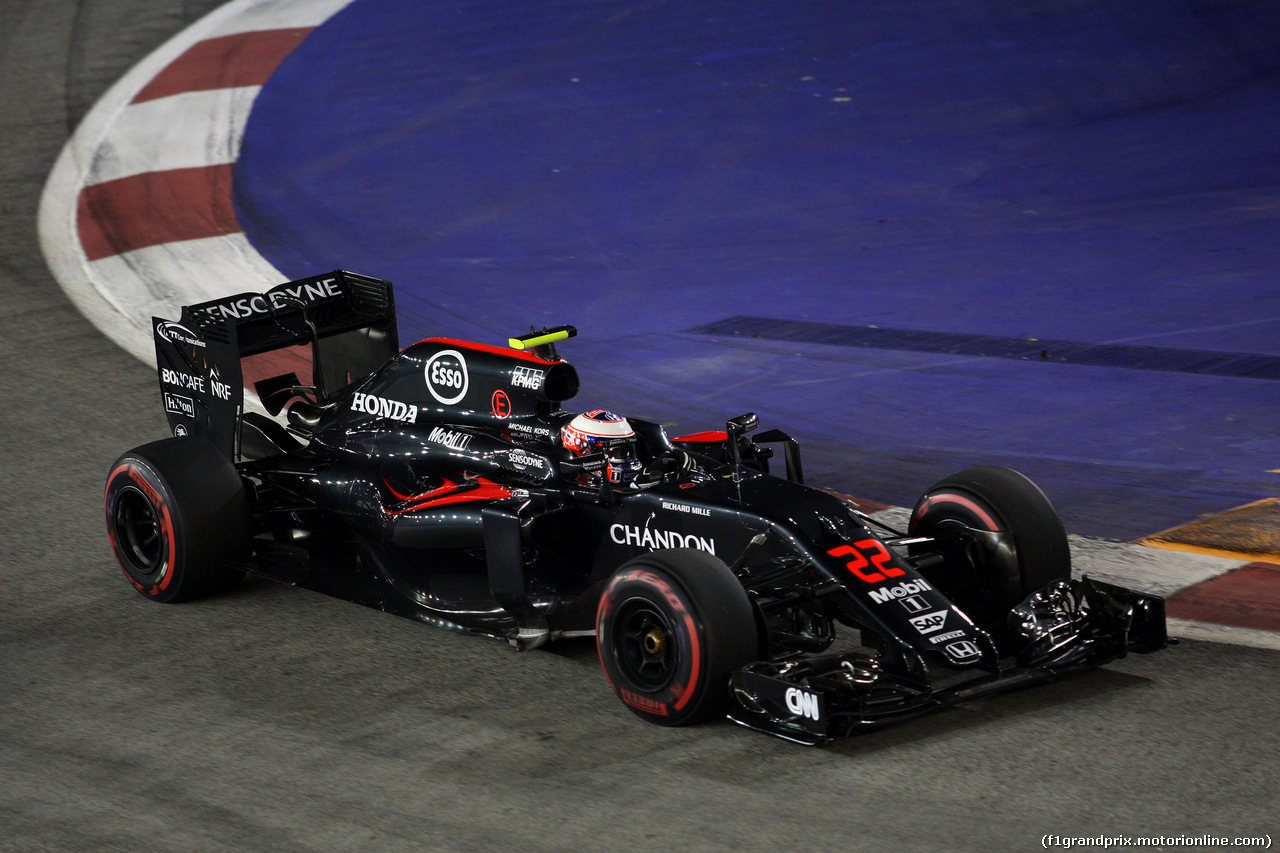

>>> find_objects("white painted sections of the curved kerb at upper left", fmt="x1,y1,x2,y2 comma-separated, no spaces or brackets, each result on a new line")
38,0,351,364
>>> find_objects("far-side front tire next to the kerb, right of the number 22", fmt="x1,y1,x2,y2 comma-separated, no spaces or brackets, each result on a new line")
908,466,1071,633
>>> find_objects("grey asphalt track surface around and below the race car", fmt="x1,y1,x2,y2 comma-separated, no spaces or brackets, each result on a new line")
0,0,1280,850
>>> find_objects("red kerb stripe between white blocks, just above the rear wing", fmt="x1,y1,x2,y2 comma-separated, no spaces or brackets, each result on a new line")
76,163,243,260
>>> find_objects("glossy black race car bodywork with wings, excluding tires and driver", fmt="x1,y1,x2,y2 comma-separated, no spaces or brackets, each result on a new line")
145,272,1164,743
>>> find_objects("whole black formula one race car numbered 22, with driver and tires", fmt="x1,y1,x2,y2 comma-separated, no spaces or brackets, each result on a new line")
106,272,1166,744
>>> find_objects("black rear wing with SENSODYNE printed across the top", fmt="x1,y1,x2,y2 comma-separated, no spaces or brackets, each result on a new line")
151,270,399,459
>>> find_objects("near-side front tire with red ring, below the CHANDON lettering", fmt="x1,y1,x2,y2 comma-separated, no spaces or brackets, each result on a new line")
595,549,759,726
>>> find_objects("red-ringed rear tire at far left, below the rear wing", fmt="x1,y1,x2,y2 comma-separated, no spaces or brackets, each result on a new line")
105,437,251,602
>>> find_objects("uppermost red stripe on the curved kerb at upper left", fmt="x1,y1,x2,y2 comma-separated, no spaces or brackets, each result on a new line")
133,27,315,104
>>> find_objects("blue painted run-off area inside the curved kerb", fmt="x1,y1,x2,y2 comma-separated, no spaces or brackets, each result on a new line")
236,0,1280,538
